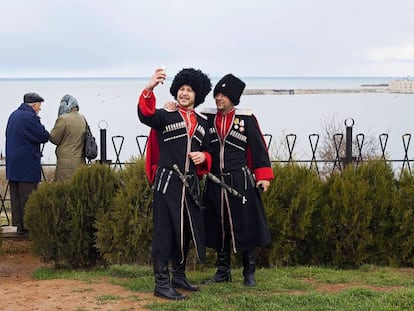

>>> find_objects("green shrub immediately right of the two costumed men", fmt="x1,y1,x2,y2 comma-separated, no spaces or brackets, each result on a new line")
263,164,321,265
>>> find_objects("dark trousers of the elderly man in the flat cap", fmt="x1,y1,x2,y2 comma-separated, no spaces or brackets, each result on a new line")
9,181,38,232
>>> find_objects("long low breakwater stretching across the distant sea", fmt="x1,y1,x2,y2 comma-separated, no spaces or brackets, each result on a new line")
243,86,396,95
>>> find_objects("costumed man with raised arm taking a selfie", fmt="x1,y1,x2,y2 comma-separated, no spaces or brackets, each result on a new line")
138,68,211,300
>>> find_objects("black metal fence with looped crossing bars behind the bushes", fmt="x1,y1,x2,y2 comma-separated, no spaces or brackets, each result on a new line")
0,119,414,225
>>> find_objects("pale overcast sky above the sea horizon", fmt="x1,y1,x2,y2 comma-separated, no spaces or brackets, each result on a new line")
0,0,414,78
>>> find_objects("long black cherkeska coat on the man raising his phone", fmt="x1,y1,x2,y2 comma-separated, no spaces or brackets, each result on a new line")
138,95,209,262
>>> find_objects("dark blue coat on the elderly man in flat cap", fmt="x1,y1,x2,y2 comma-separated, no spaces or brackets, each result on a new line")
6,104,49,182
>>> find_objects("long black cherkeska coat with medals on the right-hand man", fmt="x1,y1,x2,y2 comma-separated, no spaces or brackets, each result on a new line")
203,109,273,252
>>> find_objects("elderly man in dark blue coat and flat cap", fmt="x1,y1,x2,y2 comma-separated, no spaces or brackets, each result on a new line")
6,93,49,234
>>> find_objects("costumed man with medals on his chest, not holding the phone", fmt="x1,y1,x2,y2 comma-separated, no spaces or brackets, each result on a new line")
203,74,273,286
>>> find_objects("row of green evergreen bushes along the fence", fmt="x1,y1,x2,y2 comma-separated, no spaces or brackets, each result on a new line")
19,158,414,268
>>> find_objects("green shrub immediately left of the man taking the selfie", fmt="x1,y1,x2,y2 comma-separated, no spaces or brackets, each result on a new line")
96,159,152,264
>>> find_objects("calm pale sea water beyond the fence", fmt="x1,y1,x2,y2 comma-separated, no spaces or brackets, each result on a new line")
0,77,414,163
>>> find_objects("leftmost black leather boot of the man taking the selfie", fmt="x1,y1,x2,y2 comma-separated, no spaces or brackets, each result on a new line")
154,261,186,300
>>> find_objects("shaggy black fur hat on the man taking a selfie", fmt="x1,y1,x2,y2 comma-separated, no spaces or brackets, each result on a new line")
170,68,211,108
